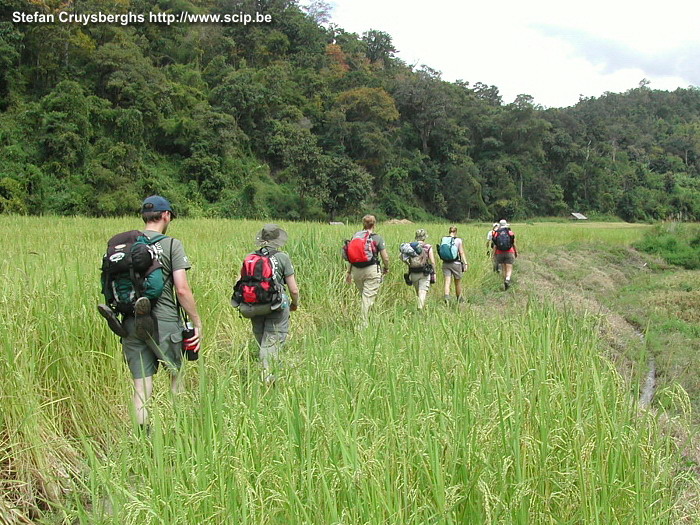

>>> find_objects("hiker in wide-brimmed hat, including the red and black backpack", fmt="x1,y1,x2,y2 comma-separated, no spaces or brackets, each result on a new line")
231,224,299,385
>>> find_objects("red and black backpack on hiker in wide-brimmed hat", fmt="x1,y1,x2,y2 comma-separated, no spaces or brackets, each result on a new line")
232,248,280,305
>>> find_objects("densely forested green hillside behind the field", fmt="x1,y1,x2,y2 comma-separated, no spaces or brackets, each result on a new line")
0,0,700,221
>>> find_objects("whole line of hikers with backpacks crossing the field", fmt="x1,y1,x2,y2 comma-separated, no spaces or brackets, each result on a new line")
98,195,517,432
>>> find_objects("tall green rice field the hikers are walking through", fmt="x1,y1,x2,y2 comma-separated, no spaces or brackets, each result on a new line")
0,216,698,525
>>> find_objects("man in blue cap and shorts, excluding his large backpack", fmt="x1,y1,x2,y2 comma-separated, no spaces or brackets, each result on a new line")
98,195,202,432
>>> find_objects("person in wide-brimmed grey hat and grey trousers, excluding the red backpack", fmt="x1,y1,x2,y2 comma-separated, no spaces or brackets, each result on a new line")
232,224,299,385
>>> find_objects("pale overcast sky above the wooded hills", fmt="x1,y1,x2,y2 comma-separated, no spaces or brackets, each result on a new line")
300,0,700,107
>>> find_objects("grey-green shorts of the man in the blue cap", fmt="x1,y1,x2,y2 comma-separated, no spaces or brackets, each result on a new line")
122,317,182,379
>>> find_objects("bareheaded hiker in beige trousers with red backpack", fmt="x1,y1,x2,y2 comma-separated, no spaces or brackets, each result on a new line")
343,215,389,326
